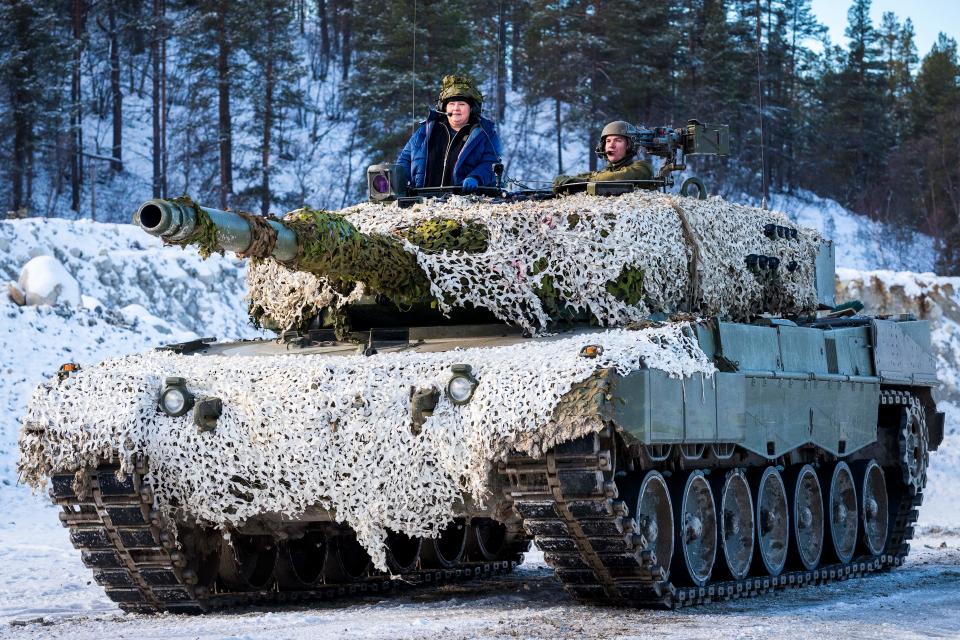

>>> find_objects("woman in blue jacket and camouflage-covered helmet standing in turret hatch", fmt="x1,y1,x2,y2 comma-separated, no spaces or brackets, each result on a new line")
397,76,503,193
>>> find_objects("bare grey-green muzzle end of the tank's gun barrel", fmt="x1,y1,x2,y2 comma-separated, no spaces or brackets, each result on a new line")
133,199,297,262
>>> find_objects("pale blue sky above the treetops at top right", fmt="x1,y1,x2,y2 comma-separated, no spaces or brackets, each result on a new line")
811,0,960,60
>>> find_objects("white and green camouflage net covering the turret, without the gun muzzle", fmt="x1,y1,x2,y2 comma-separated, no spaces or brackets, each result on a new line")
248,192,822,333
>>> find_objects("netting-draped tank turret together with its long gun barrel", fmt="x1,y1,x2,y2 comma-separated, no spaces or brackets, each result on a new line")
135,192,833,335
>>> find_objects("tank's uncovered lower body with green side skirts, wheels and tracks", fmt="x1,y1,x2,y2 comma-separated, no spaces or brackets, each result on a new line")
31,318,943,613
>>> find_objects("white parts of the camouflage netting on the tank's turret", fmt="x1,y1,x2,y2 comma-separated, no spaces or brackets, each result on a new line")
249,191,822,333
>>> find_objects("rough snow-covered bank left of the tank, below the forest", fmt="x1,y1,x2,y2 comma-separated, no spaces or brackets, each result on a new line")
0,218,262,484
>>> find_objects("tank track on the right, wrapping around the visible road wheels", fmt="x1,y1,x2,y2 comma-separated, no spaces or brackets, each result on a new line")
501,391,923,609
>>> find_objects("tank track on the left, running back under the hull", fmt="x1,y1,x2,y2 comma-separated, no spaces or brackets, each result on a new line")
50,463,520,614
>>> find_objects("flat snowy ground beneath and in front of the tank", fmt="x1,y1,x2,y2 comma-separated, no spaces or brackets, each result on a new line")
0,482,960,640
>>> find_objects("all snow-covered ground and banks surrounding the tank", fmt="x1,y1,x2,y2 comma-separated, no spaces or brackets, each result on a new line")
0,196,960,640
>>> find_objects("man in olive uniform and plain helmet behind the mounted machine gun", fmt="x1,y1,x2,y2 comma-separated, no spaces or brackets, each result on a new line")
553,120,656,193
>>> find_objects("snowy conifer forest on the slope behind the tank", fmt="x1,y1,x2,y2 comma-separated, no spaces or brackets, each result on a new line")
0,0,960,275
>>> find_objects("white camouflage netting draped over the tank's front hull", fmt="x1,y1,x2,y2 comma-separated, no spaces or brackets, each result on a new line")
20,323,714,569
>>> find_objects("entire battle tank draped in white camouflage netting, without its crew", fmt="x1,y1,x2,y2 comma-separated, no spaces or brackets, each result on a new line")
19,192,943,613
